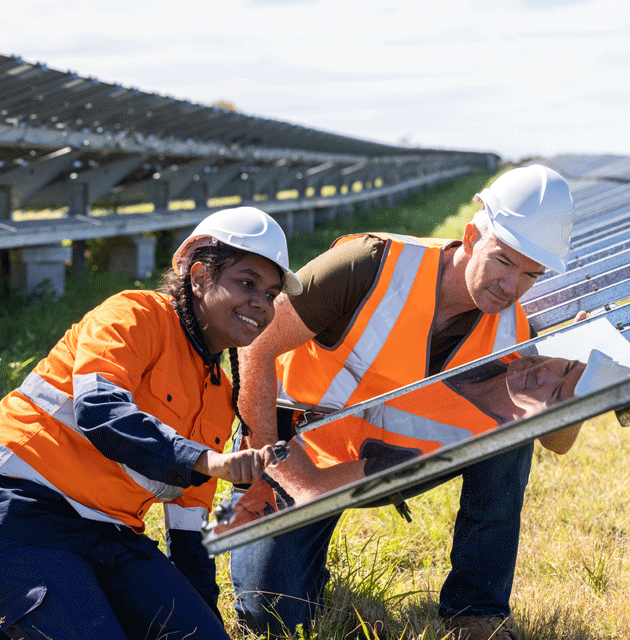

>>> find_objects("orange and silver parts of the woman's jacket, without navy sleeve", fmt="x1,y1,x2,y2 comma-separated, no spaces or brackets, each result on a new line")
0,291,234,532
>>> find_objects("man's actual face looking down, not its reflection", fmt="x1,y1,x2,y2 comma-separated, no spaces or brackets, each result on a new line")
464,223,545,315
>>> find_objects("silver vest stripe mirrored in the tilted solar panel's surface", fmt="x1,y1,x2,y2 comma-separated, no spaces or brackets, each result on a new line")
357,404,473,446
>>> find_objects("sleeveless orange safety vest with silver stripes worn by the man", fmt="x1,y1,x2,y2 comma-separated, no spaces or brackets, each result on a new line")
276,233,530,463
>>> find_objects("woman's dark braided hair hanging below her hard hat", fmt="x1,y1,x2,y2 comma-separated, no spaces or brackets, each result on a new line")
158,242,250,435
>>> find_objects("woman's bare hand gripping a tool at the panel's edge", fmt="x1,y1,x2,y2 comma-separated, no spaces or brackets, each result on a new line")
194,445,278,484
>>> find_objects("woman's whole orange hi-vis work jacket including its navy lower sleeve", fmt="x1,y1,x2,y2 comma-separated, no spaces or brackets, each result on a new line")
0,291,234,532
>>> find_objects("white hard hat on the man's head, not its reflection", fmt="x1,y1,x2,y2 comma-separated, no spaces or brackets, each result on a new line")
477,164,573,273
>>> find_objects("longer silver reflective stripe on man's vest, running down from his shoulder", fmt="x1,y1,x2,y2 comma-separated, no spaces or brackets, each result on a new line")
318,244,426,409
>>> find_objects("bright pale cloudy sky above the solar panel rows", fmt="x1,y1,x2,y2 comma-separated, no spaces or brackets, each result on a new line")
0,0,630,160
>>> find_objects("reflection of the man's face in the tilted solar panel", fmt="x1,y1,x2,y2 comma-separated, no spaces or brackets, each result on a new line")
506,356,586,415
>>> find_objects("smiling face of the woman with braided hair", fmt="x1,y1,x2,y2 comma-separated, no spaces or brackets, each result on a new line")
190,253,282,353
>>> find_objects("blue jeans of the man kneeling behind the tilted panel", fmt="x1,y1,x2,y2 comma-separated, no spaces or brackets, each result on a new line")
230,443,534,634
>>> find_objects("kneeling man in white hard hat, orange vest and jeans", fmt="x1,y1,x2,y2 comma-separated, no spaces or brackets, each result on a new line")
231,165,573,640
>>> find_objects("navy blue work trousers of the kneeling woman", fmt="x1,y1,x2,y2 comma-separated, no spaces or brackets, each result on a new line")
0,538,229,640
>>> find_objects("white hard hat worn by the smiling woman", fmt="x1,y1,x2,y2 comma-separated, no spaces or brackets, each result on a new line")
173,207,302,294
